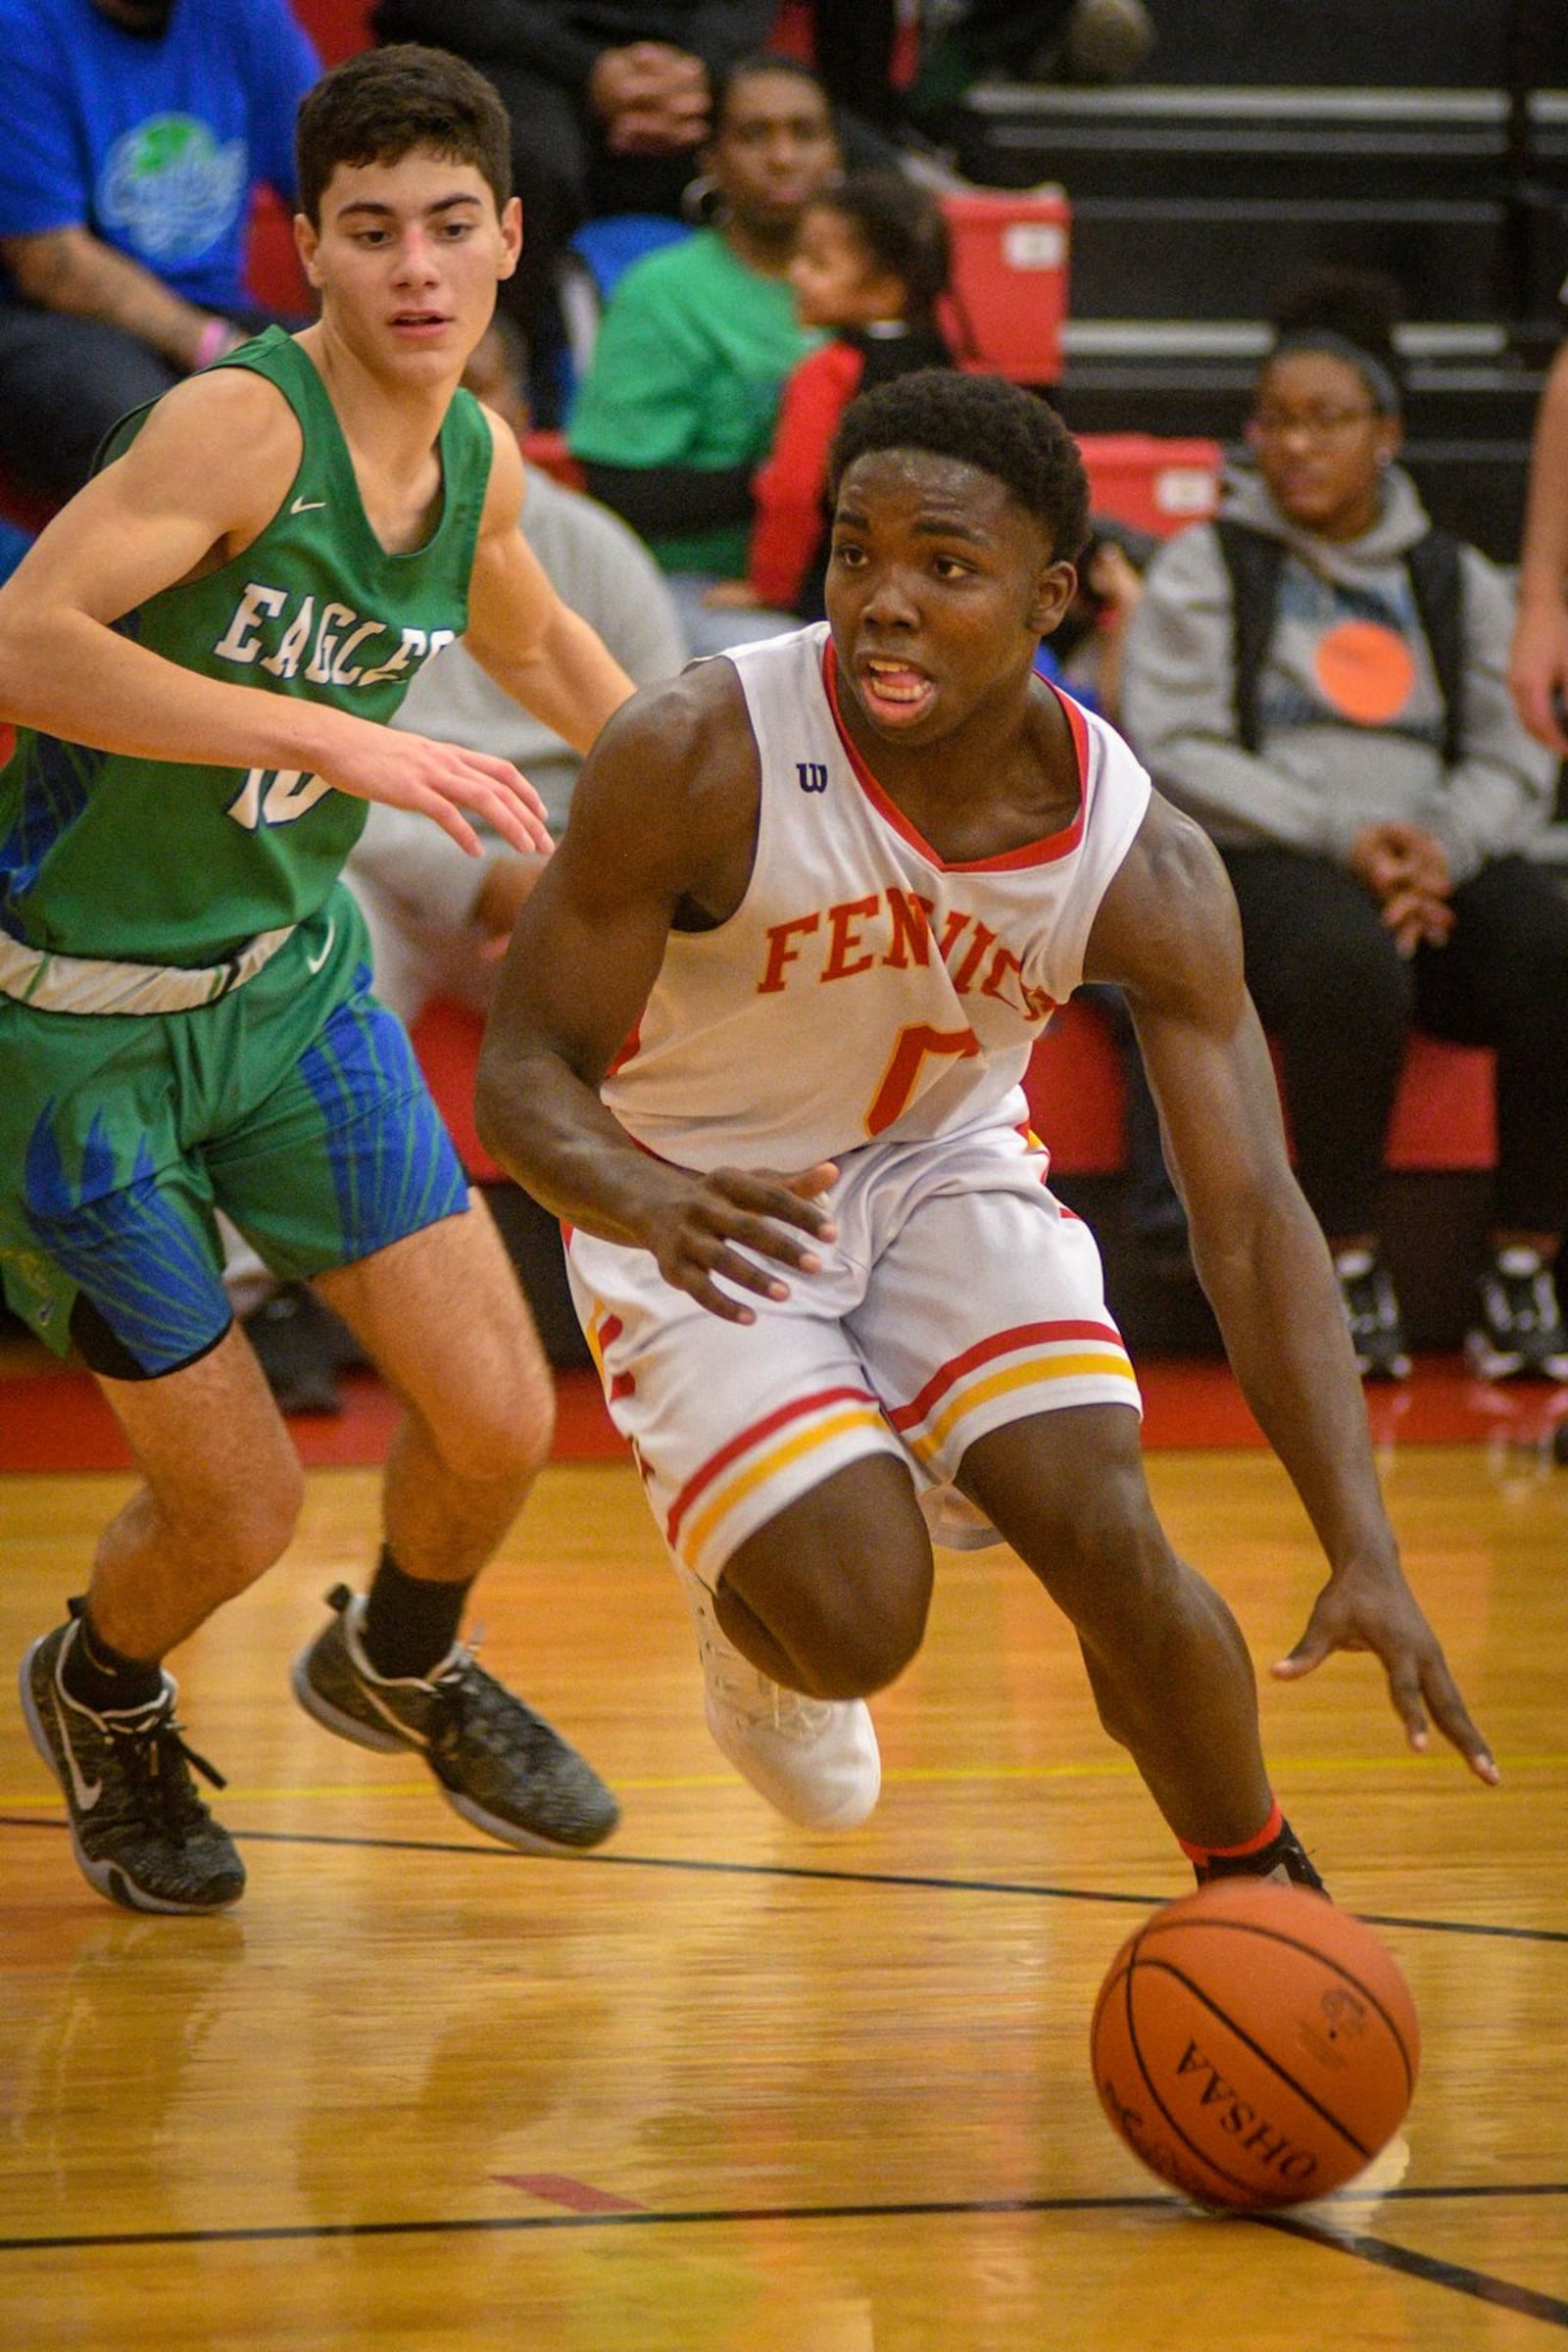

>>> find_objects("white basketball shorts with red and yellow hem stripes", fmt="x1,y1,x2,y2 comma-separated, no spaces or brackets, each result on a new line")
566,1127,1143,1586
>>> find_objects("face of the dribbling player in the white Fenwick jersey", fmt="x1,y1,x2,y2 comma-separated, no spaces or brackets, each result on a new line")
827,449,1077,746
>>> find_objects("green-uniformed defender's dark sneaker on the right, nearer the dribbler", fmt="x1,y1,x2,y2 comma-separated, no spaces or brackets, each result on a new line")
294,1586,620,1853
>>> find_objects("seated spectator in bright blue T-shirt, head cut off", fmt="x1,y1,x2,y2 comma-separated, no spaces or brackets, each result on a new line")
0,0,319,499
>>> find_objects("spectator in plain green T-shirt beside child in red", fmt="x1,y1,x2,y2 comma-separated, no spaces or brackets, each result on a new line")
569,57,839,654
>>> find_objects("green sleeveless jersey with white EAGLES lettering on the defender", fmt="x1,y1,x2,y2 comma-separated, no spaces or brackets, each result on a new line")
0,327,491,964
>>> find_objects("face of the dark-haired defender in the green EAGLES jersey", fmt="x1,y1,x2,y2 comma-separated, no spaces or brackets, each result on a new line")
296,148,522,378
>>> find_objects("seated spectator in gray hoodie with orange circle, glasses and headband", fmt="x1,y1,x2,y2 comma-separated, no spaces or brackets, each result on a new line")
1124,313,1568,1381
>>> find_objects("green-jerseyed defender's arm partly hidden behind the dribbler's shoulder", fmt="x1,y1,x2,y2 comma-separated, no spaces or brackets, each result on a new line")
464,416,632,751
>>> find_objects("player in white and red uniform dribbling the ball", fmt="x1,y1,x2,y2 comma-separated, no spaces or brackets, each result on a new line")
479,371,1497,1884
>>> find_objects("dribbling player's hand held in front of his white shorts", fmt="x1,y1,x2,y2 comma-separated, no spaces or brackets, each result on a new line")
644,1159,839,1324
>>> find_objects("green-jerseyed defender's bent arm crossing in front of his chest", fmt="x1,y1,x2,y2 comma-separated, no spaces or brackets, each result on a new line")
0,369,550,854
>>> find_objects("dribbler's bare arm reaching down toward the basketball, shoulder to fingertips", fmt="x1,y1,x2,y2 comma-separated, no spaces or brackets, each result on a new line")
1086,800,1497,1783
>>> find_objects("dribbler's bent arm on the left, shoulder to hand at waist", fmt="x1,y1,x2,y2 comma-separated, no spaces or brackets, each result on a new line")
477,661,837,1322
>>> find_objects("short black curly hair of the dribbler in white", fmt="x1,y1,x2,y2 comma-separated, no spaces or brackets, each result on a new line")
827,367,1089,563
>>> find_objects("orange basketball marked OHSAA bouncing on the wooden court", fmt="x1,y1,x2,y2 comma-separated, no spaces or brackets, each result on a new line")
1091,1880,1420,2209
